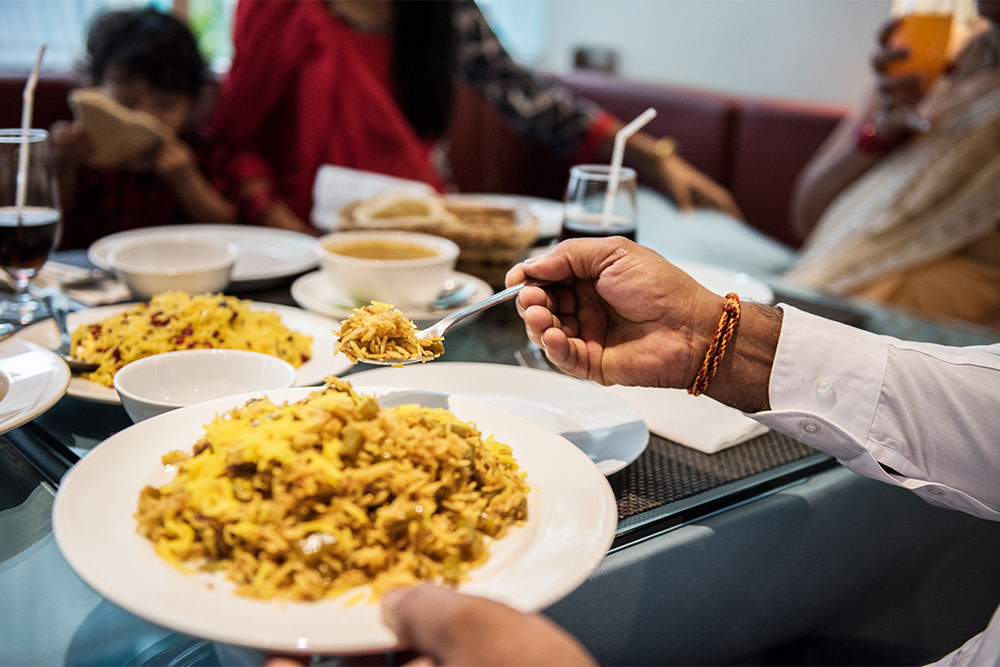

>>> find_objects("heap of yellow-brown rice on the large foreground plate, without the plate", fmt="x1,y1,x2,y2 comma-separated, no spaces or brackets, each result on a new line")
135,378,528,600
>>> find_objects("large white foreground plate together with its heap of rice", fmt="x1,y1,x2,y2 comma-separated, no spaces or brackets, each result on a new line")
52,385,617,654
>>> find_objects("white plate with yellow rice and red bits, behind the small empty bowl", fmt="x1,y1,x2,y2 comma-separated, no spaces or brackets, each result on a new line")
17,292,352,404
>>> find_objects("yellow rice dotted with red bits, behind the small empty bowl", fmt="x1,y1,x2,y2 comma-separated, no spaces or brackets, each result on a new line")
71,292,312,387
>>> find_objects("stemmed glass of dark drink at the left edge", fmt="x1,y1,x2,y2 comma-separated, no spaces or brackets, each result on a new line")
0,129,62,324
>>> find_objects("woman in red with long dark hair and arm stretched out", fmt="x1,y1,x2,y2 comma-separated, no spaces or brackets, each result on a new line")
212,0,739,231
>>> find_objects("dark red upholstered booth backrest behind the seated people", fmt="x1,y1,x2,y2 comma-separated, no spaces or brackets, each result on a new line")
0,71,845,243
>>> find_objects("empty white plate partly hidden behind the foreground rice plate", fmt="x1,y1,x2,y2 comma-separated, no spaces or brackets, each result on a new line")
348,362,649,475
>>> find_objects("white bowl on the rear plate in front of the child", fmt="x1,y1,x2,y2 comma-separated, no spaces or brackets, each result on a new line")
108,235,239,299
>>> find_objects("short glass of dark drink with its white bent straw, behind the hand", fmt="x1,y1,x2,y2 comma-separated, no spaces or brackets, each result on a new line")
559,109,656,241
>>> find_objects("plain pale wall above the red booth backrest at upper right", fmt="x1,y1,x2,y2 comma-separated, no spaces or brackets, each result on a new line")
480,0,891,105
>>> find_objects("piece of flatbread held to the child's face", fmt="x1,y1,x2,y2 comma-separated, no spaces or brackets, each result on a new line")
69,88,173,169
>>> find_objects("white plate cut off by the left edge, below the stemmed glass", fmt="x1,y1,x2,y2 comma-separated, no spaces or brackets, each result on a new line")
0,338,69,433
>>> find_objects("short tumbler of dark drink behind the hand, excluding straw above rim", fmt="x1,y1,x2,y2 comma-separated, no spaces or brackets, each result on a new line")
559,164,636,241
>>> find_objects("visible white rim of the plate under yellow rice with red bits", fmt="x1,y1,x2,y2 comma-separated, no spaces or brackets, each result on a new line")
15,297,352,404
